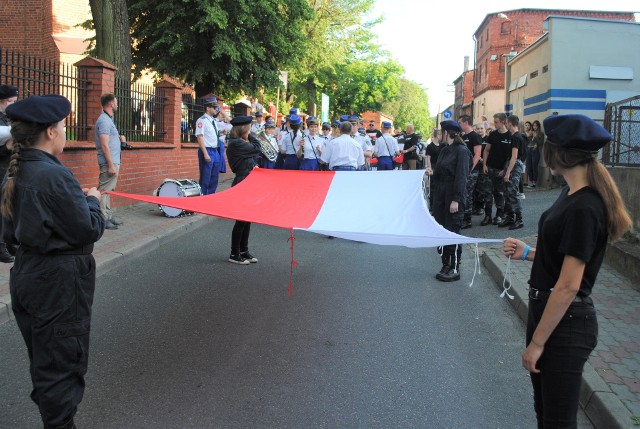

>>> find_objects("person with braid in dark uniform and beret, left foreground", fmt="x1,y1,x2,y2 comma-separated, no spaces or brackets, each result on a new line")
0,95,106,429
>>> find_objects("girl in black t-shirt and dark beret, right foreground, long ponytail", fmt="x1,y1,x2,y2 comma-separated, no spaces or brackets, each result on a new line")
503,115,631,428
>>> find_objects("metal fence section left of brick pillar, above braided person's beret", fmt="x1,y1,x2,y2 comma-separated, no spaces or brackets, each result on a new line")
0,47,89,140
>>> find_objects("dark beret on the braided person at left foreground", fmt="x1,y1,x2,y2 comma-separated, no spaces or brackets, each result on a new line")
6,95,71,124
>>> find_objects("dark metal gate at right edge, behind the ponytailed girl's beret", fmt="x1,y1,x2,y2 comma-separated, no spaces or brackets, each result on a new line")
602,96,640,167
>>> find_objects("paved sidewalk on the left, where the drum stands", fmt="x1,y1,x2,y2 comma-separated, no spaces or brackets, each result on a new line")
0,174,234,324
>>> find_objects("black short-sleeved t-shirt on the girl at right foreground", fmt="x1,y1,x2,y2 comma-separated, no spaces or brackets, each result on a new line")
529,187,608,296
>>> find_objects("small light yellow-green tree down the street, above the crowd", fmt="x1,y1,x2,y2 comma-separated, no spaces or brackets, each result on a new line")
382,78,434,134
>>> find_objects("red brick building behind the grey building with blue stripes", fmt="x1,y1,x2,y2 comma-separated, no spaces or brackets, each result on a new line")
470,9,635,122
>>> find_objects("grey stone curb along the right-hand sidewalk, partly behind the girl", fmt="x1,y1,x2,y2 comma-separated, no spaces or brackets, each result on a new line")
482,249,633,429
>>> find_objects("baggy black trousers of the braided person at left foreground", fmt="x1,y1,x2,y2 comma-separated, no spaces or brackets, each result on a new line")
9,251,96,428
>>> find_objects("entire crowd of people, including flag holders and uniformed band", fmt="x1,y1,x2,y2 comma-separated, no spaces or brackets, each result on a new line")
0,85,631,429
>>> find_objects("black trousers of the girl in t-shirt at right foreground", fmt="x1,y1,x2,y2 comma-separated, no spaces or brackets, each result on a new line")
527,298,598,429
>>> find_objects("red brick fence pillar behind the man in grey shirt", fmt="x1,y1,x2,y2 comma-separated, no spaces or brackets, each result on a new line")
74,57,116,133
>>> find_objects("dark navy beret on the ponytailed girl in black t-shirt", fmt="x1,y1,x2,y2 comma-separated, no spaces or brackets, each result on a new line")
543,115,612,152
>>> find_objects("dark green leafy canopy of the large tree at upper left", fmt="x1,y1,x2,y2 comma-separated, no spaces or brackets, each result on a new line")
129,0,314,94
